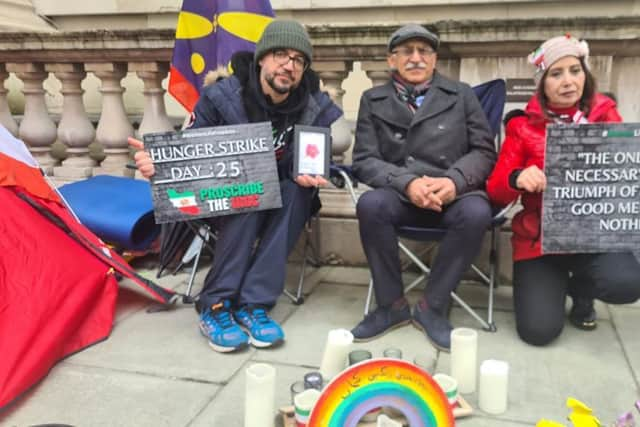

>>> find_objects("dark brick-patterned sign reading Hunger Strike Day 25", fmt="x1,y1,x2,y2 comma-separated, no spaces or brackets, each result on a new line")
144,122,282,224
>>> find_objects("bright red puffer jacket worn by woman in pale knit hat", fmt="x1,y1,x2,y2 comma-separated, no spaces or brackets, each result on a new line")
487,94,622,261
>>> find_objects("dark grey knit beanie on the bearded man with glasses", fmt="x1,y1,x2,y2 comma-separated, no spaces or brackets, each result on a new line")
253,19,313,64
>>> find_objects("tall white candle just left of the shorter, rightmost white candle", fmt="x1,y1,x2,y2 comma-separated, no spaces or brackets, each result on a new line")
450,328,478,393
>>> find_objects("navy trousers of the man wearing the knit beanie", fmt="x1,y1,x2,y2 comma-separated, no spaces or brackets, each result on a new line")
200,180,315,307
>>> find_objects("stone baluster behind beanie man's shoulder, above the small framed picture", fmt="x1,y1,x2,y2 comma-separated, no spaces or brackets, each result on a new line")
313,61,351,163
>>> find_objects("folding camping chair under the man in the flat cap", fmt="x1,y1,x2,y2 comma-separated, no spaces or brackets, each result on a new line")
338,79,512,332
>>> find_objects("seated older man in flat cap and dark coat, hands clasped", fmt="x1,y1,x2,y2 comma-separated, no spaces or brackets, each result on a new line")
352,24,496,351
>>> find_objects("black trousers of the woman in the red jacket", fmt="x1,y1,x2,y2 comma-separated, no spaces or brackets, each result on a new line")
513,253,640,345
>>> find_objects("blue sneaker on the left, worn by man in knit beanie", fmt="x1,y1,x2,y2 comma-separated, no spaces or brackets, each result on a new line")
200,300,249,353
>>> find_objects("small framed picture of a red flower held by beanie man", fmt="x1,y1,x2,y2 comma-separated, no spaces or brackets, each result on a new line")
293,125,331,178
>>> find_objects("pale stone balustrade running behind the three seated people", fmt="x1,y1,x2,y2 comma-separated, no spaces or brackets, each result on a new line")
0,16,640,273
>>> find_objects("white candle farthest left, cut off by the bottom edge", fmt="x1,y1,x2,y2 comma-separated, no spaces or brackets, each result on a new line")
244,363,276,427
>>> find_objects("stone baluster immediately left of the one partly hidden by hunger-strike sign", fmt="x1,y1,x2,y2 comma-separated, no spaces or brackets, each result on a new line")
85,62,134,176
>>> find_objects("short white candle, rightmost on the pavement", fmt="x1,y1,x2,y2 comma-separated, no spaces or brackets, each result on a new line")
478,359,509,414
